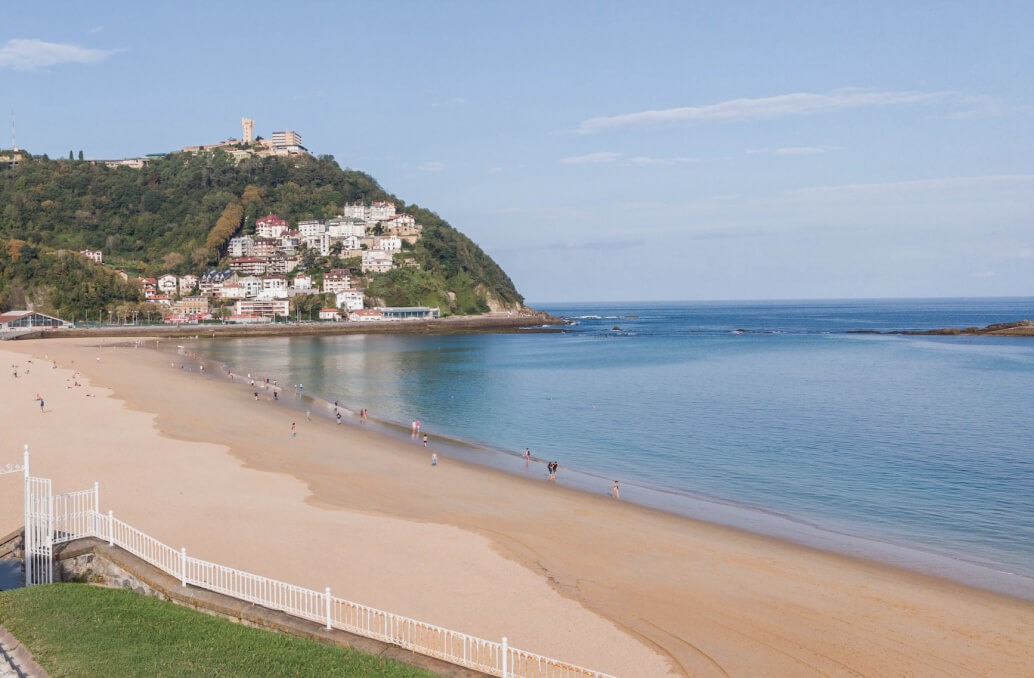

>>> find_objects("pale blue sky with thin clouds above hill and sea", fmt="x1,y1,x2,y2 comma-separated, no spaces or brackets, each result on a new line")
0,1,1034,302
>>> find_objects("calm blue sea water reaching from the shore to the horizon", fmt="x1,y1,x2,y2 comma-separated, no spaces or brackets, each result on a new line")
192,299,1034,597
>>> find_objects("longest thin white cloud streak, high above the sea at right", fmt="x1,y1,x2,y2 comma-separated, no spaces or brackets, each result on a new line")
578,88,966,134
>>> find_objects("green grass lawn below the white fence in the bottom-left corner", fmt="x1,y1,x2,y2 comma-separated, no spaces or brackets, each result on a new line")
0,584,434,678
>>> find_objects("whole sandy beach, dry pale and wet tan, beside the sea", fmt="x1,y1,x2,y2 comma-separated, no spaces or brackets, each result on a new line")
0,339,1034,678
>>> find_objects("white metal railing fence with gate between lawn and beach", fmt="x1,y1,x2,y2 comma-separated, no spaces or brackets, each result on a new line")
12,444,613,678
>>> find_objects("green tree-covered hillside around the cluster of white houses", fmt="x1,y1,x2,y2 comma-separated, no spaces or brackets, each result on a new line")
0,151,523,315
